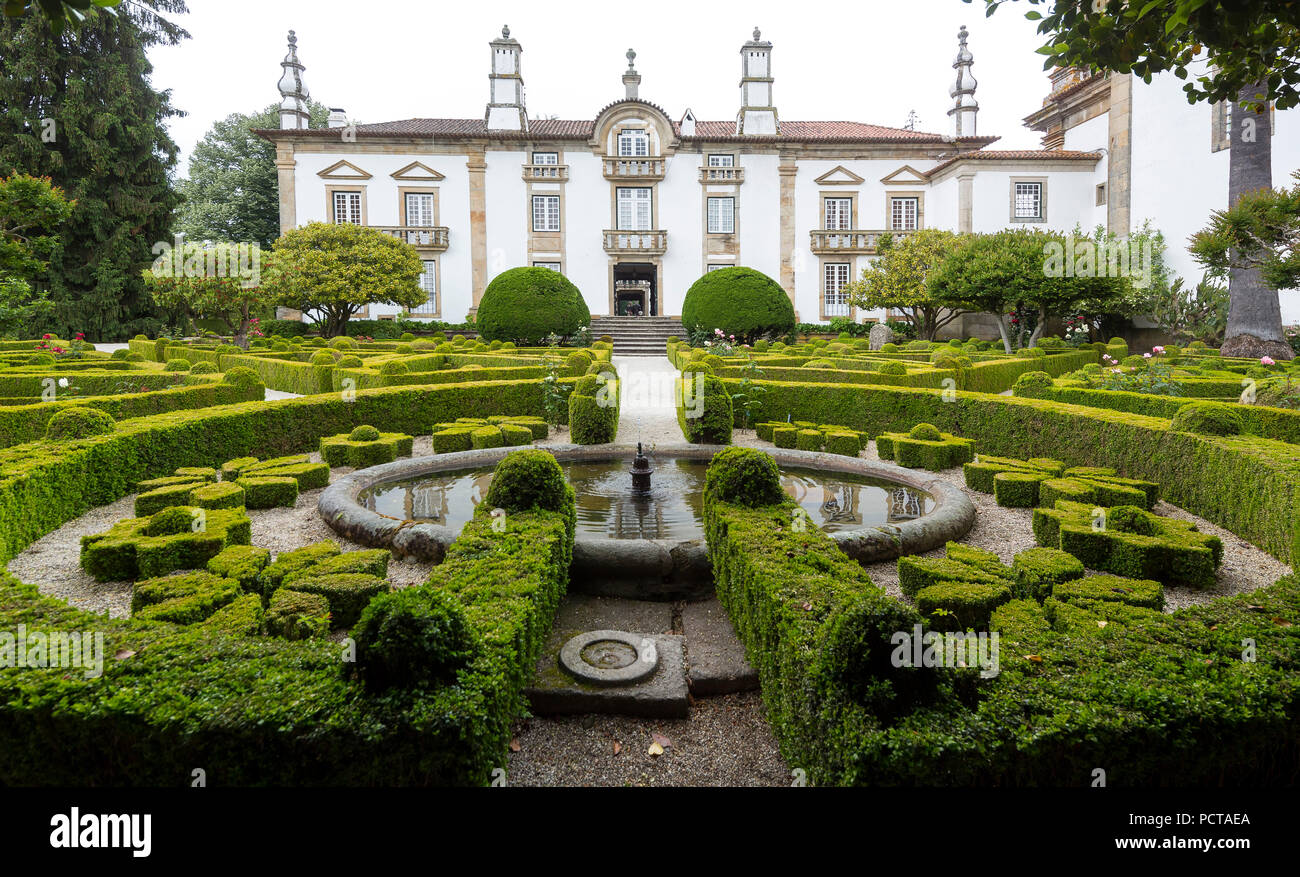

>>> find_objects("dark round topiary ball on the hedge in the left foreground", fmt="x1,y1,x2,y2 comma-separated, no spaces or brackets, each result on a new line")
353,587,478,691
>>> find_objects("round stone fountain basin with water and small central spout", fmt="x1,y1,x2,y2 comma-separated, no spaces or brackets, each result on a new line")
317,444,975,599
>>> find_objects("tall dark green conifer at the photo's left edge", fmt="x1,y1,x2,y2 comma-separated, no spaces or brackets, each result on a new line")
0,0,189,340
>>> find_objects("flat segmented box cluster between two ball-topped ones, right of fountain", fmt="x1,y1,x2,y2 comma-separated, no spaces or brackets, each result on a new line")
962,455,1160,511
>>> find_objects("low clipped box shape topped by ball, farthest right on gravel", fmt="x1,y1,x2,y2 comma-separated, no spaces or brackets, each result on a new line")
1034,499,1223,587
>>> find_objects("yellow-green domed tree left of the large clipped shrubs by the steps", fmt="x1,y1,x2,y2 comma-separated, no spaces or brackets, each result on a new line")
261,222,423,337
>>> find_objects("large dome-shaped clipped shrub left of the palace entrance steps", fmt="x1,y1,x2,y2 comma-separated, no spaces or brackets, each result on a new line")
478,268,592,347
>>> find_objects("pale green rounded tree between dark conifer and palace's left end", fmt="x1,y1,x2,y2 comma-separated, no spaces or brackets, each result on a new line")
176,101,329,248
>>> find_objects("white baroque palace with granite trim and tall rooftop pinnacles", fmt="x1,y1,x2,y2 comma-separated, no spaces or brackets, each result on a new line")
257,27,1300,330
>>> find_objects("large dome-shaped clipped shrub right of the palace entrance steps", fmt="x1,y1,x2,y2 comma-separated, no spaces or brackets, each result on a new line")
681,268,794,343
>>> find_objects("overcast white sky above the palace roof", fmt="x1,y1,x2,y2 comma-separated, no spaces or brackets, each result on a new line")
151,0,1066,175
